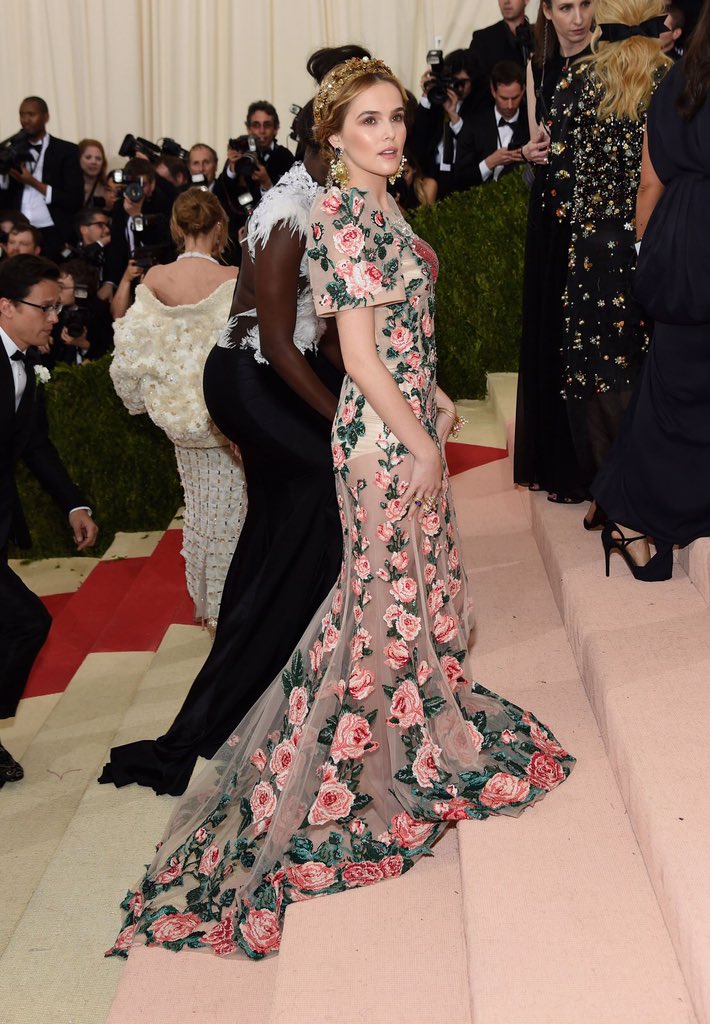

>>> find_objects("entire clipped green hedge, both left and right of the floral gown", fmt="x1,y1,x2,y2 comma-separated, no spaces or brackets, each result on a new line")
12,174,528,558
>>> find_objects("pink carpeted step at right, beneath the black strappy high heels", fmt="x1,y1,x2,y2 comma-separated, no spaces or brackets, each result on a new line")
525,493,710,1024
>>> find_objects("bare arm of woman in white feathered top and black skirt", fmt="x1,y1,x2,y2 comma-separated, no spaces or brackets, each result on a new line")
255,226,338,422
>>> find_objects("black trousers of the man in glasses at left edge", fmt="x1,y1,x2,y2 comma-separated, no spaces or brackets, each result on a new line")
0,552,52,718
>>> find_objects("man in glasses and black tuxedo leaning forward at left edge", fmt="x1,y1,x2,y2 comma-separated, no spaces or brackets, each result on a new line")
0,255,98,787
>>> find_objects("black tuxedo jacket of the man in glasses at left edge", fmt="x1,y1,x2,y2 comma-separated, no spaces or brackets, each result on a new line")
0,344,86,552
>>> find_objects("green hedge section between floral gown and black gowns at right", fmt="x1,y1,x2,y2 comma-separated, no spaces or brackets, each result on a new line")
411,167,529,398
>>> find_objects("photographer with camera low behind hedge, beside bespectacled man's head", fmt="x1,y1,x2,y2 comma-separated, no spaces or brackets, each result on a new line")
42,259,114,370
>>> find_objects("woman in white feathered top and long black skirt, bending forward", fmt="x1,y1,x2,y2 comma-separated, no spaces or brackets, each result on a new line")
99,68,365,796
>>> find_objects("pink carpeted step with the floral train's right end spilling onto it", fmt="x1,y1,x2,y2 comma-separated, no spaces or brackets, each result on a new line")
455,467,696,1024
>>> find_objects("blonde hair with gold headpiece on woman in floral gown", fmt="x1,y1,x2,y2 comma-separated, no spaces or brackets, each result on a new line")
314,57,408,160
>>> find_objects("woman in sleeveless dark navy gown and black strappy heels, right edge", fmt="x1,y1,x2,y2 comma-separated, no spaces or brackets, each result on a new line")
592,3,710,581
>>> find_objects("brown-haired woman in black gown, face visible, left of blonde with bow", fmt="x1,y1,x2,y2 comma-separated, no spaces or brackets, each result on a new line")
514,0,593,502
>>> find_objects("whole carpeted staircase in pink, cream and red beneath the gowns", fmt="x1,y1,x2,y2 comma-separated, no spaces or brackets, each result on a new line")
0,375,710,1024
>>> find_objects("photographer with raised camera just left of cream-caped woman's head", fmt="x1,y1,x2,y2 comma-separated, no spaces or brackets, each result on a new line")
103,157,174,296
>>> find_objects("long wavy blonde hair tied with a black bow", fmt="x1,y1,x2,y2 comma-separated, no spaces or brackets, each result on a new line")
585,0,672,121
